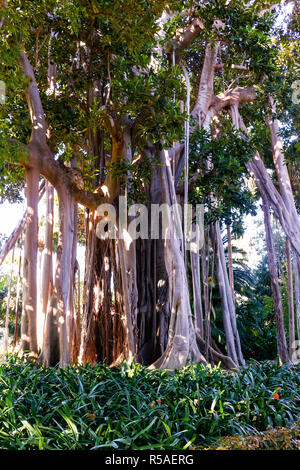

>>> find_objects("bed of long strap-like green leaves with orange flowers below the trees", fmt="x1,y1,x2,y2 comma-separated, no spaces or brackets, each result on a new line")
0,356,300,450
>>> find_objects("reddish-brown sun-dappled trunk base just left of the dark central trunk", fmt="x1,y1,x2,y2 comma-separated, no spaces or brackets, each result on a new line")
80,212,129,364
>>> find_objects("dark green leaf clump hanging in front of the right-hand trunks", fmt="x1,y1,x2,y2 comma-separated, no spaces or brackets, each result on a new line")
190,121,256,224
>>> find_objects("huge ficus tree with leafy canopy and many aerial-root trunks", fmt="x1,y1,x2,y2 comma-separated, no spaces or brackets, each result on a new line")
0,0,300,369
